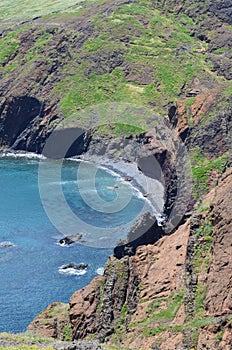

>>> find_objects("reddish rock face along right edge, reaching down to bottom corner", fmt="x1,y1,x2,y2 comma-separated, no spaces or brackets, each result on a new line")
197,169,232,350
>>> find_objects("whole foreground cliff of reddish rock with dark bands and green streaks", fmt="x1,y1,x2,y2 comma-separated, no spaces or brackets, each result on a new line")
29,168,232,350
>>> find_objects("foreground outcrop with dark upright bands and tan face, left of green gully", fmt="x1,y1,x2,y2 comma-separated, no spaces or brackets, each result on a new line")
70,219,189,349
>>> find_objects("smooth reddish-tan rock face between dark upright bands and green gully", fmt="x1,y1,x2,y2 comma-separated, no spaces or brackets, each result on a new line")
132,222,189,310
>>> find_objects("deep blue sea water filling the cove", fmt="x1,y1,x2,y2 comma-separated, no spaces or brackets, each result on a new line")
0,158,144,332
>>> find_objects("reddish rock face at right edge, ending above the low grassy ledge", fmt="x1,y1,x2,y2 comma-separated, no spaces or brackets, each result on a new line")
206,169,232,316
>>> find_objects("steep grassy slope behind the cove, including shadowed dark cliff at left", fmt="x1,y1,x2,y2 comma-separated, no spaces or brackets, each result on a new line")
0,0,231,152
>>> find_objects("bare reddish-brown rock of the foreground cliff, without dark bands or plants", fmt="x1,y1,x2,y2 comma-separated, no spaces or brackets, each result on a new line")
67,170,232,350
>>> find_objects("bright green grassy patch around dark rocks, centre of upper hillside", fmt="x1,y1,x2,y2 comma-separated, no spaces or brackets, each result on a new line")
44,1,224,121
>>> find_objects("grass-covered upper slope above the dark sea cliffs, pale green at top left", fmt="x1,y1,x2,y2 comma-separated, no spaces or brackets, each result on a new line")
0,0,231,129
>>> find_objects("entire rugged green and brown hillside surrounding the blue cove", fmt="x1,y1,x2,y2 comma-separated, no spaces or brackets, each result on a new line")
0,0,232,350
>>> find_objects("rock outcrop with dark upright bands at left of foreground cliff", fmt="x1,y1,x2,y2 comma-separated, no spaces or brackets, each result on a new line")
70,256,138,340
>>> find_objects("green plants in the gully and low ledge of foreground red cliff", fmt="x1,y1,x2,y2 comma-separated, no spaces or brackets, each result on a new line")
130,202,222,344
